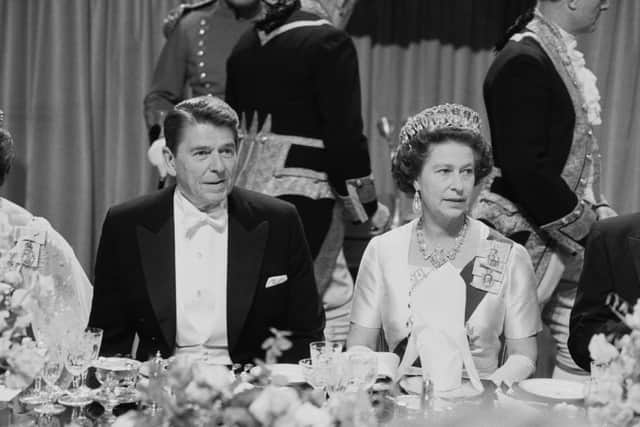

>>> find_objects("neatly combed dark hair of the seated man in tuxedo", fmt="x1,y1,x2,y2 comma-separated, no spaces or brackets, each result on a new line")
164,95,240,154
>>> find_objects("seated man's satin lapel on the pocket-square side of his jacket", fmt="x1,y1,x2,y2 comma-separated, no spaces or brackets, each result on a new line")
227,190,269,352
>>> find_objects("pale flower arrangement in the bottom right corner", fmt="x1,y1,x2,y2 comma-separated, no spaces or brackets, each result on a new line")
585,300,640,427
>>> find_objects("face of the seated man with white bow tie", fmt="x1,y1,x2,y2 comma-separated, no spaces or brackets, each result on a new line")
164,123,237,211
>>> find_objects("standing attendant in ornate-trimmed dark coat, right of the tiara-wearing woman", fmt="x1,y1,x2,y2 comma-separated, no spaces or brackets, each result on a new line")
473,0,615,377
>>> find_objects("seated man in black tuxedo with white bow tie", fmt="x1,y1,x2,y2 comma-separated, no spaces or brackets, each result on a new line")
89,96,324,364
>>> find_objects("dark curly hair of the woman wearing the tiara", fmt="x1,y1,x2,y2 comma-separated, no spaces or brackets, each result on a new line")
391,128,493,195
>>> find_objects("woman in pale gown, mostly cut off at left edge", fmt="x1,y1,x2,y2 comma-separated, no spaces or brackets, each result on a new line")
0,118,93,332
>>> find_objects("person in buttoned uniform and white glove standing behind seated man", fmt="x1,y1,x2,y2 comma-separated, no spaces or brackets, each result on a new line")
144,0,261,180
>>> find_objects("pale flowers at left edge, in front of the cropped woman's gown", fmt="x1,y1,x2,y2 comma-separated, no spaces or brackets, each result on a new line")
0,248,45,389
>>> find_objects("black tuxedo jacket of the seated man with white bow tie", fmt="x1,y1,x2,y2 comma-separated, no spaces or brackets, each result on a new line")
89,187,324,363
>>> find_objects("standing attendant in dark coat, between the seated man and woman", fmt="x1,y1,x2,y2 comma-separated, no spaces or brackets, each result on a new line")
226,0,389,340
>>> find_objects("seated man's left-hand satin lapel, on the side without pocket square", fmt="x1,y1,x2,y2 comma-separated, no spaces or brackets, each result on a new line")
136,191,176,348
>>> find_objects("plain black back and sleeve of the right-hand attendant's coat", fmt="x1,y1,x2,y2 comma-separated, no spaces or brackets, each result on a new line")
484,37,578,231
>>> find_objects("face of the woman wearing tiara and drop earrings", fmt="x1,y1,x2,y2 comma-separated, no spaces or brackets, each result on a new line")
415,140,475,221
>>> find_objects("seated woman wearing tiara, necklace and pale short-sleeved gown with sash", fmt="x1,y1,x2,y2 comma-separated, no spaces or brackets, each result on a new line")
347,104,541,384
